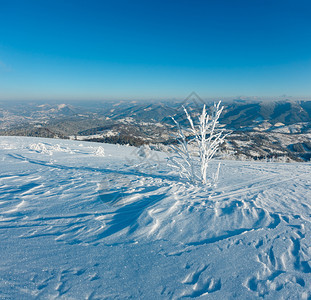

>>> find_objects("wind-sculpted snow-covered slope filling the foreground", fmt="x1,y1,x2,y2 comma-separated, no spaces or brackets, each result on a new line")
0,137,311,299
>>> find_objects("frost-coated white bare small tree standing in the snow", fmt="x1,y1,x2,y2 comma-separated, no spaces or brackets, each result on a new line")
169,101,228,185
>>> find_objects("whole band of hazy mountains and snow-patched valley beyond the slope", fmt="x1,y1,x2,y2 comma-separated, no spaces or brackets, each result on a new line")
0,99,311,161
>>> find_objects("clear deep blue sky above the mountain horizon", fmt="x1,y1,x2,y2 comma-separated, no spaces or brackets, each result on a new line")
0,0,311,100
